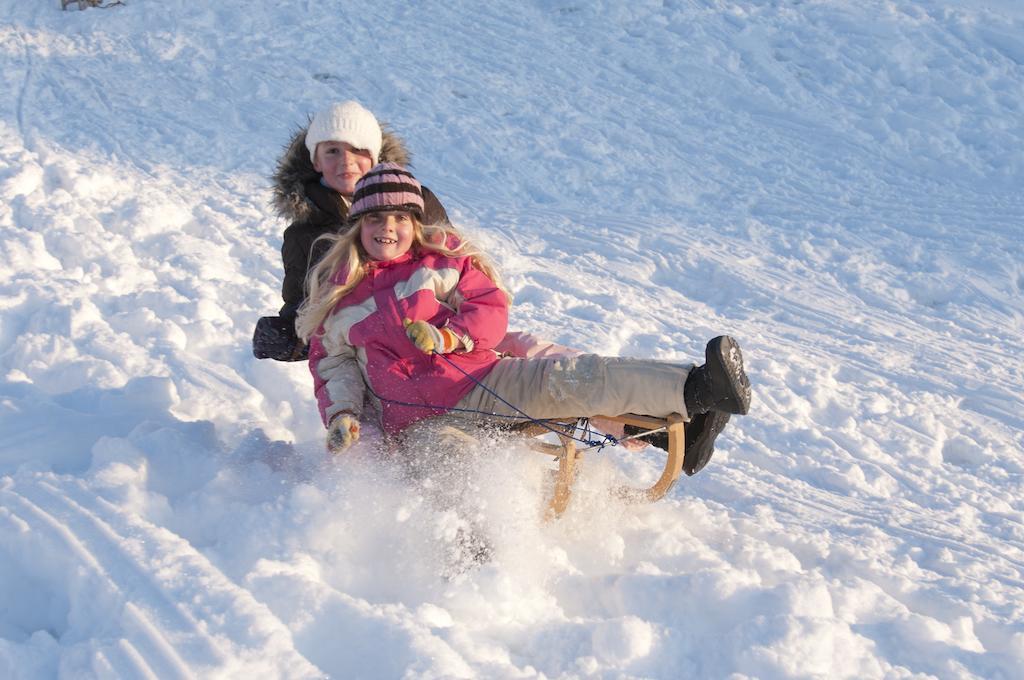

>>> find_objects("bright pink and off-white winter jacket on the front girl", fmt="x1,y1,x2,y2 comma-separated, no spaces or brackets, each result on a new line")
309,249,509,433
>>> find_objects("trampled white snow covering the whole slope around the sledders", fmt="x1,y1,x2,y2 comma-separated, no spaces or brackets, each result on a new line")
0,0,1024,679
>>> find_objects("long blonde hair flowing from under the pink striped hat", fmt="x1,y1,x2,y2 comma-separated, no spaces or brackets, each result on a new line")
295,215,512,342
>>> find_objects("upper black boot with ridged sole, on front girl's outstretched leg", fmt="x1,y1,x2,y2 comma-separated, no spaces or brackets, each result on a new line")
683,335,751,419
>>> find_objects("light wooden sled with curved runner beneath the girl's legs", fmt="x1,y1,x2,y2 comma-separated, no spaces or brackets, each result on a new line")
521,414,686,520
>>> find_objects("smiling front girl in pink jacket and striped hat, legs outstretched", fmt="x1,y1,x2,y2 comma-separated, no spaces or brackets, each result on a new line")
297,163,751,474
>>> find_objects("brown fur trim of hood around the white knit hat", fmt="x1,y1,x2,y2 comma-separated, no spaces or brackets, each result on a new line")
271,123,412,222
